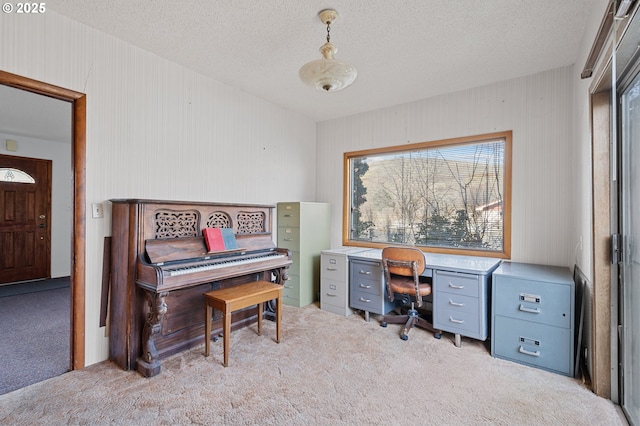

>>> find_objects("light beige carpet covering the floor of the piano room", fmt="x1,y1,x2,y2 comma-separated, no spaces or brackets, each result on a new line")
0,305,624,425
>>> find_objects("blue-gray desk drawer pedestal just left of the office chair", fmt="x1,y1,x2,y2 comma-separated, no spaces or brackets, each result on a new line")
349,250,394,321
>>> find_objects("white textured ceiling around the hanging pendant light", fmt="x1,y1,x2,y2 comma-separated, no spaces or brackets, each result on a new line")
0,0,604,144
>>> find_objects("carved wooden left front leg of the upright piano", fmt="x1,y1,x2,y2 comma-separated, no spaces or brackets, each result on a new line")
136,290,169,377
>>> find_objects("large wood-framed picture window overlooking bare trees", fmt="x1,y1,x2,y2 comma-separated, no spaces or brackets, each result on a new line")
343,131,511,258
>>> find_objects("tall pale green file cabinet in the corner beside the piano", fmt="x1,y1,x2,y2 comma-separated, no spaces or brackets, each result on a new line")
277,202,331,307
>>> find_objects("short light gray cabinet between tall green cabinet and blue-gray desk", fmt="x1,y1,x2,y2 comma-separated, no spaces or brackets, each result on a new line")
320,247,366,317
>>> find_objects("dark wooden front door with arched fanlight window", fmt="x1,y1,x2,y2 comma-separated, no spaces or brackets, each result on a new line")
0,155,51,285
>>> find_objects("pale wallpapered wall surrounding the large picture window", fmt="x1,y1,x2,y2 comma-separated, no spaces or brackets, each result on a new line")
317,66,576,267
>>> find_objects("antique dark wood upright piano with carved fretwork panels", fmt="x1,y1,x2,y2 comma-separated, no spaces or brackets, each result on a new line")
109,199,292,377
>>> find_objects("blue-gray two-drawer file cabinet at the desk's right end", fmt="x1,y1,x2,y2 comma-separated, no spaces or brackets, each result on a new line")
491,263,575,377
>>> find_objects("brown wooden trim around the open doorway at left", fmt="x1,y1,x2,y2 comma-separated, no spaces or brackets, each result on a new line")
0,71,87,370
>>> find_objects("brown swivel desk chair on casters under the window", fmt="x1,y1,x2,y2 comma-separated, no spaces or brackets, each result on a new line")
380,247,441,340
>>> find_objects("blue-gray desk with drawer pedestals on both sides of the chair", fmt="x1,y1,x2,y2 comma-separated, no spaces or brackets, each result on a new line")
349,249,501,347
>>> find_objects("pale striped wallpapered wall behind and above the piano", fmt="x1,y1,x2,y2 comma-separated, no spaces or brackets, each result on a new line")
0,11,316,365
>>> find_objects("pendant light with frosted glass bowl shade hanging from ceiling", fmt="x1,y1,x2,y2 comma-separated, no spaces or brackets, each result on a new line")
299,9,358,92
